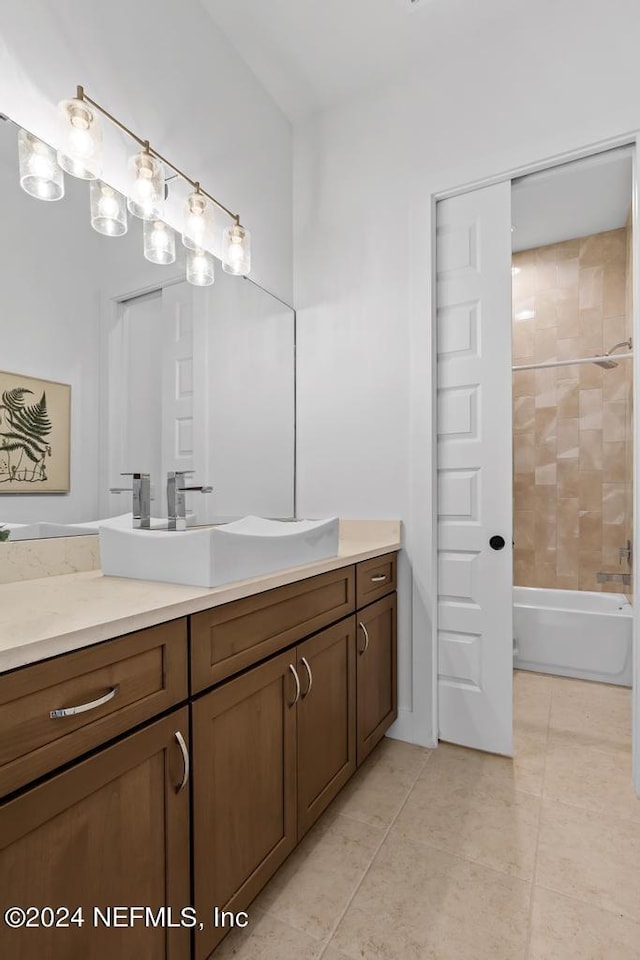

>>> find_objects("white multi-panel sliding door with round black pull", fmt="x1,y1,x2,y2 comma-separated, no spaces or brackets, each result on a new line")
436,182,513,756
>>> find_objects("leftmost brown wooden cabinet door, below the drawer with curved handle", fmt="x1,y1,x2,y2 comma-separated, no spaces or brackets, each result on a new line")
0,708,190,960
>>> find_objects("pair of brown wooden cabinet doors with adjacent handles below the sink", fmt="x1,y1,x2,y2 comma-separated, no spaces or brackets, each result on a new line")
192,617,356,960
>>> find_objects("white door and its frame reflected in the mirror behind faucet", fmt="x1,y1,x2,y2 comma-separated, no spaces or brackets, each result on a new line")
103,282,207,523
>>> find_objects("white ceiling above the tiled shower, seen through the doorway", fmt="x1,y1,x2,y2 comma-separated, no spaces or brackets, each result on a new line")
511,148,632,252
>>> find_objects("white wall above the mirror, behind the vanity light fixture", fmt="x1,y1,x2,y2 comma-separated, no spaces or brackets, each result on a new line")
0,0,292,302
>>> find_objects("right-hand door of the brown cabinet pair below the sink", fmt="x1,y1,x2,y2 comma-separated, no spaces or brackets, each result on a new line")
297,617,356,839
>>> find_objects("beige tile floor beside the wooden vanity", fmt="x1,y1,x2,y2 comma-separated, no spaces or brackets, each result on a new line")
216,673,640,960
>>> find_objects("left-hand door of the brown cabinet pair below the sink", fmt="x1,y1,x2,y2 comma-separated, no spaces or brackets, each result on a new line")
192,648,297,960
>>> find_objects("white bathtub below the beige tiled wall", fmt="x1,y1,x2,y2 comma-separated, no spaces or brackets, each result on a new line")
513,587,633,687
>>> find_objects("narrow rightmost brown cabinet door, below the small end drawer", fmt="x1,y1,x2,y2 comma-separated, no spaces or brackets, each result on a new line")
356,593,398,765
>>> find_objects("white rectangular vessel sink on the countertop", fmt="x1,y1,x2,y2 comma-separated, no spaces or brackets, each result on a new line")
100,517,338,587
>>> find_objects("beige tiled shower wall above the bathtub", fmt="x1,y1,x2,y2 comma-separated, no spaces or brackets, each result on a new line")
513,228,633,593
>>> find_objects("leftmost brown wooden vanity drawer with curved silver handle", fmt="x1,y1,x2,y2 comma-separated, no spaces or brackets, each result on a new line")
0,618,188,796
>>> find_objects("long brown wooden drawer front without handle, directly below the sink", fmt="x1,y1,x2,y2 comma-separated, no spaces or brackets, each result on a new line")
191,567,355,693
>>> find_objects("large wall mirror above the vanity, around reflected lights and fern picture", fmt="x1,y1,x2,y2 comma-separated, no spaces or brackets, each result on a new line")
0,121,295,539
